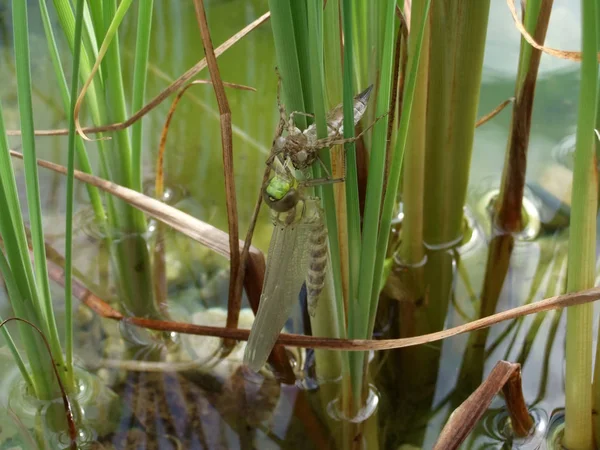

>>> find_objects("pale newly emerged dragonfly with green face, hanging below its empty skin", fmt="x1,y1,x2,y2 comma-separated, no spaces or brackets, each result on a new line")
244,174,328,371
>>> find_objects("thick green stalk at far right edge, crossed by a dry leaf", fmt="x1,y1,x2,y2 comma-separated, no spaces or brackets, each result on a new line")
563,0,598,450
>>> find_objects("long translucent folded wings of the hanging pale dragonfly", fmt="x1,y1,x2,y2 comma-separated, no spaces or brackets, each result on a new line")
244,217,311,371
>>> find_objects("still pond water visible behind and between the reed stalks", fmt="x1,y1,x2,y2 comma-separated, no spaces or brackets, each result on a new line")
0,0,592,449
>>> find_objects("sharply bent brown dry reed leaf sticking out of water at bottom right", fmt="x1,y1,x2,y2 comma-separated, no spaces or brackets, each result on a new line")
433,361,533,450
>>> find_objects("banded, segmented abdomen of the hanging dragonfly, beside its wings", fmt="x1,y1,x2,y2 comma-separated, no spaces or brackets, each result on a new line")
306,221,328,315
